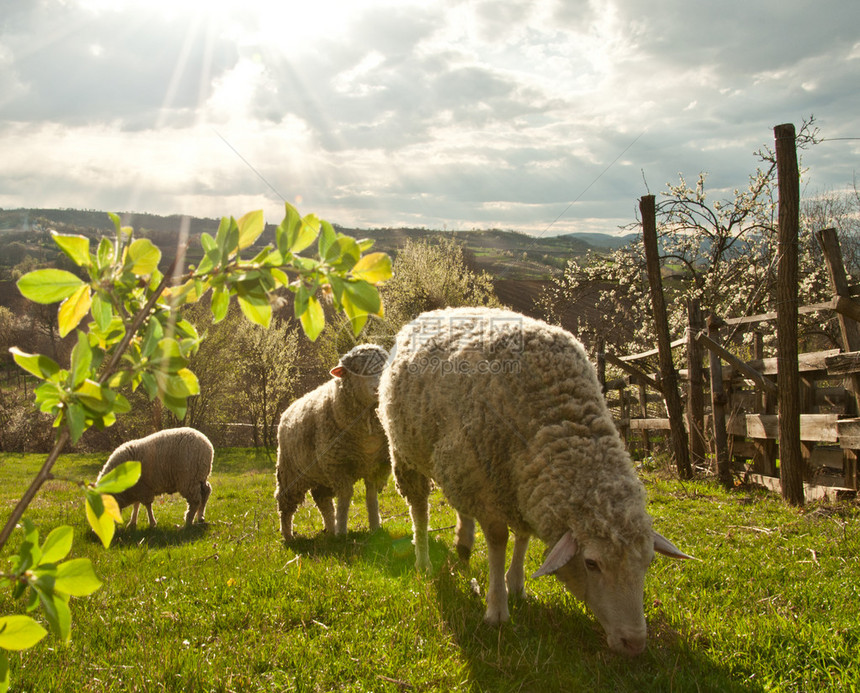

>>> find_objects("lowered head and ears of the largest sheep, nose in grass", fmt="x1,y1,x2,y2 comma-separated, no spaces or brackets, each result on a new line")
534,530,690,656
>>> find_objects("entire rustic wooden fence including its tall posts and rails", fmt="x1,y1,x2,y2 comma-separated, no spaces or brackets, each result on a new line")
598,124,860,504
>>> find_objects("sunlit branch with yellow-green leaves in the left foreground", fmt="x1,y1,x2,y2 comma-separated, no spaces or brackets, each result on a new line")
0,204,391,693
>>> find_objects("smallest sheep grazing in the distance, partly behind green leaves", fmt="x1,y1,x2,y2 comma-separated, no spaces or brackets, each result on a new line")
98,428,215,529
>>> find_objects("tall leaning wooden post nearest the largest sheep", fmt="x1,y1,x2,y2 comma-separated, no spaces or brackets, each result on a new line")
639,195,693,479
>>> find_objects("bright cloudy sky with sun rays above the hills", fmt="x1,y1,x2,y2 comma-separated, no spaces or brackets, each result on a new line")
0,0,860,235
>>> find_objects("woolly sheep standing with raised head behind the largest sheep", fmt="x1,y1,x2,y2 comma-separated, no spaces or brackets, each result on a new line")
275,344,391,541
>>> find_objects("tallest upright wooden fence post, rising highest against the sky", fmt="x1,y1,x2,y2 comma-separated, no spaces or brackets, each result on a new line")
773,123,804,505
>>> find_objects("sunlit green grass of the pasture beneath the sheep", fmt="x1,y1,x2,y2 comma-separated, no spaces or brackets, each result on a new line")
0,449,860,691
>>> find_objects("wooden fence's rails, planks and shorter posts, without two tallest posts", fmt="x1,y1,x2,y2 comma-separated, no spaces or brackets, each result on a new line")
602,224,860,498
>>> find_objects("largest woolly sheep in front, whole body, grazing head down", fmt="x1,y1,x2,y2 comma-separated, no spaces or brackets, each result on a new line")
379,308,689,655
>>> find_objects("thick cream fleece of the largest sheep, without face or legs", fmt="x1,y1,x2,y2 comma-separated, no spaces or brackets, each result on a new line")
379,308,653,559
